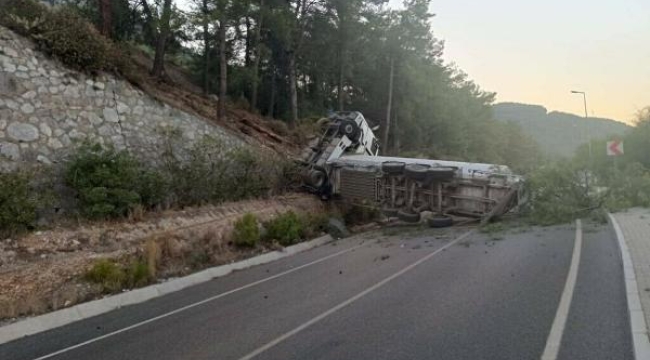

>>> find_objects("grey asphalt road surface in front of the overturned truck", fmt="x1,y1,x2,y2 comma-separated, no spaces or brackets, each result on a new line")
0,221,633,360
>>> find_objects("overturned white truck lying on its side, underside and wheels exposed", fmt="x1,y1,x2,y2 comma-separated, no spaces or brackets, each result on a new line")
300,111,523,227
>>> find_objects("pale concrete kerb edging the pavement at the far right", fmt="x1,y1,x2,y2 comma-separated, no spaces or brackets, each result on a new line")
607,213,650,360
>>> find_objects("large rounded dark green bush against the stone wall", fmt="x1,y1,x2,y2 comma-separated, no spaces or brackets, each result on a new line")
65,143,165,219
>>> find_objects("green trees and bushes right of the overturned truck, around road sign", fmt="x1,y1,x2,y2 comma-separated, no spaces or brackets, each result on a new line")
527,108,650,225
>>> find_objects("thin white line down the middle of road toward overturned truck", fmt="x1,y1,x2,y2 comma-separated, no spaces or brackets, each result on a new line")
239,231,472,360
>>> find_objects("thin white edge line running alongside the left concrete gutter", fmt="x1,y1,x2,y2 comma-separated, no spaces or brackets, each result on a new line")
34,242,373,360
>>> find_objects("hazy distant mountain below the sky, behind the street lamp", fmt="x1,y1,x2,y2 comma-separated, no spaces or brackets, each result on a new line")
493,103,630,157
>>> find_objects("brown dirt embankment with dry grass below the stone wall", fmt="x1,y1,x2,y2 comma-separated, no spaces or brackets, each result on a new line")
0,194,325,321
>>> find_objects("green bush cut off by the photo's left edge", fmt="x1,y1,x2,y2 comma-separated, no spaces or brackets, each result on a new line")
0,172,39,237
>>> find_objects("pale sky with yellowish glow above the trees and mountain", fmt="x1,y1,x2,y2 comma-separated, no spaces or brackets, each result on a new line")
390,0,650,122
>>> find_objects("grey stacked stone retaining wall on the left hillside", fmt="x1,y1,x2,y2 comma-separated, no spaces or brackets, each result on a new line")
0,27,244,169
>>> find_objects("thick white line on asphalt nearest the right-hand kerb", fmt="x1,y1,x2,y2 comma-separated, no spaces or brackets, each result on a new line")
542,220,582,360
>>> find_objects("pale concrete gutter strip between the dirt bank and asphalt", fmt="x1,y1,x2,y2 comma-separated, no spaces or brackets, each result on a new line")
0,235,333,345
